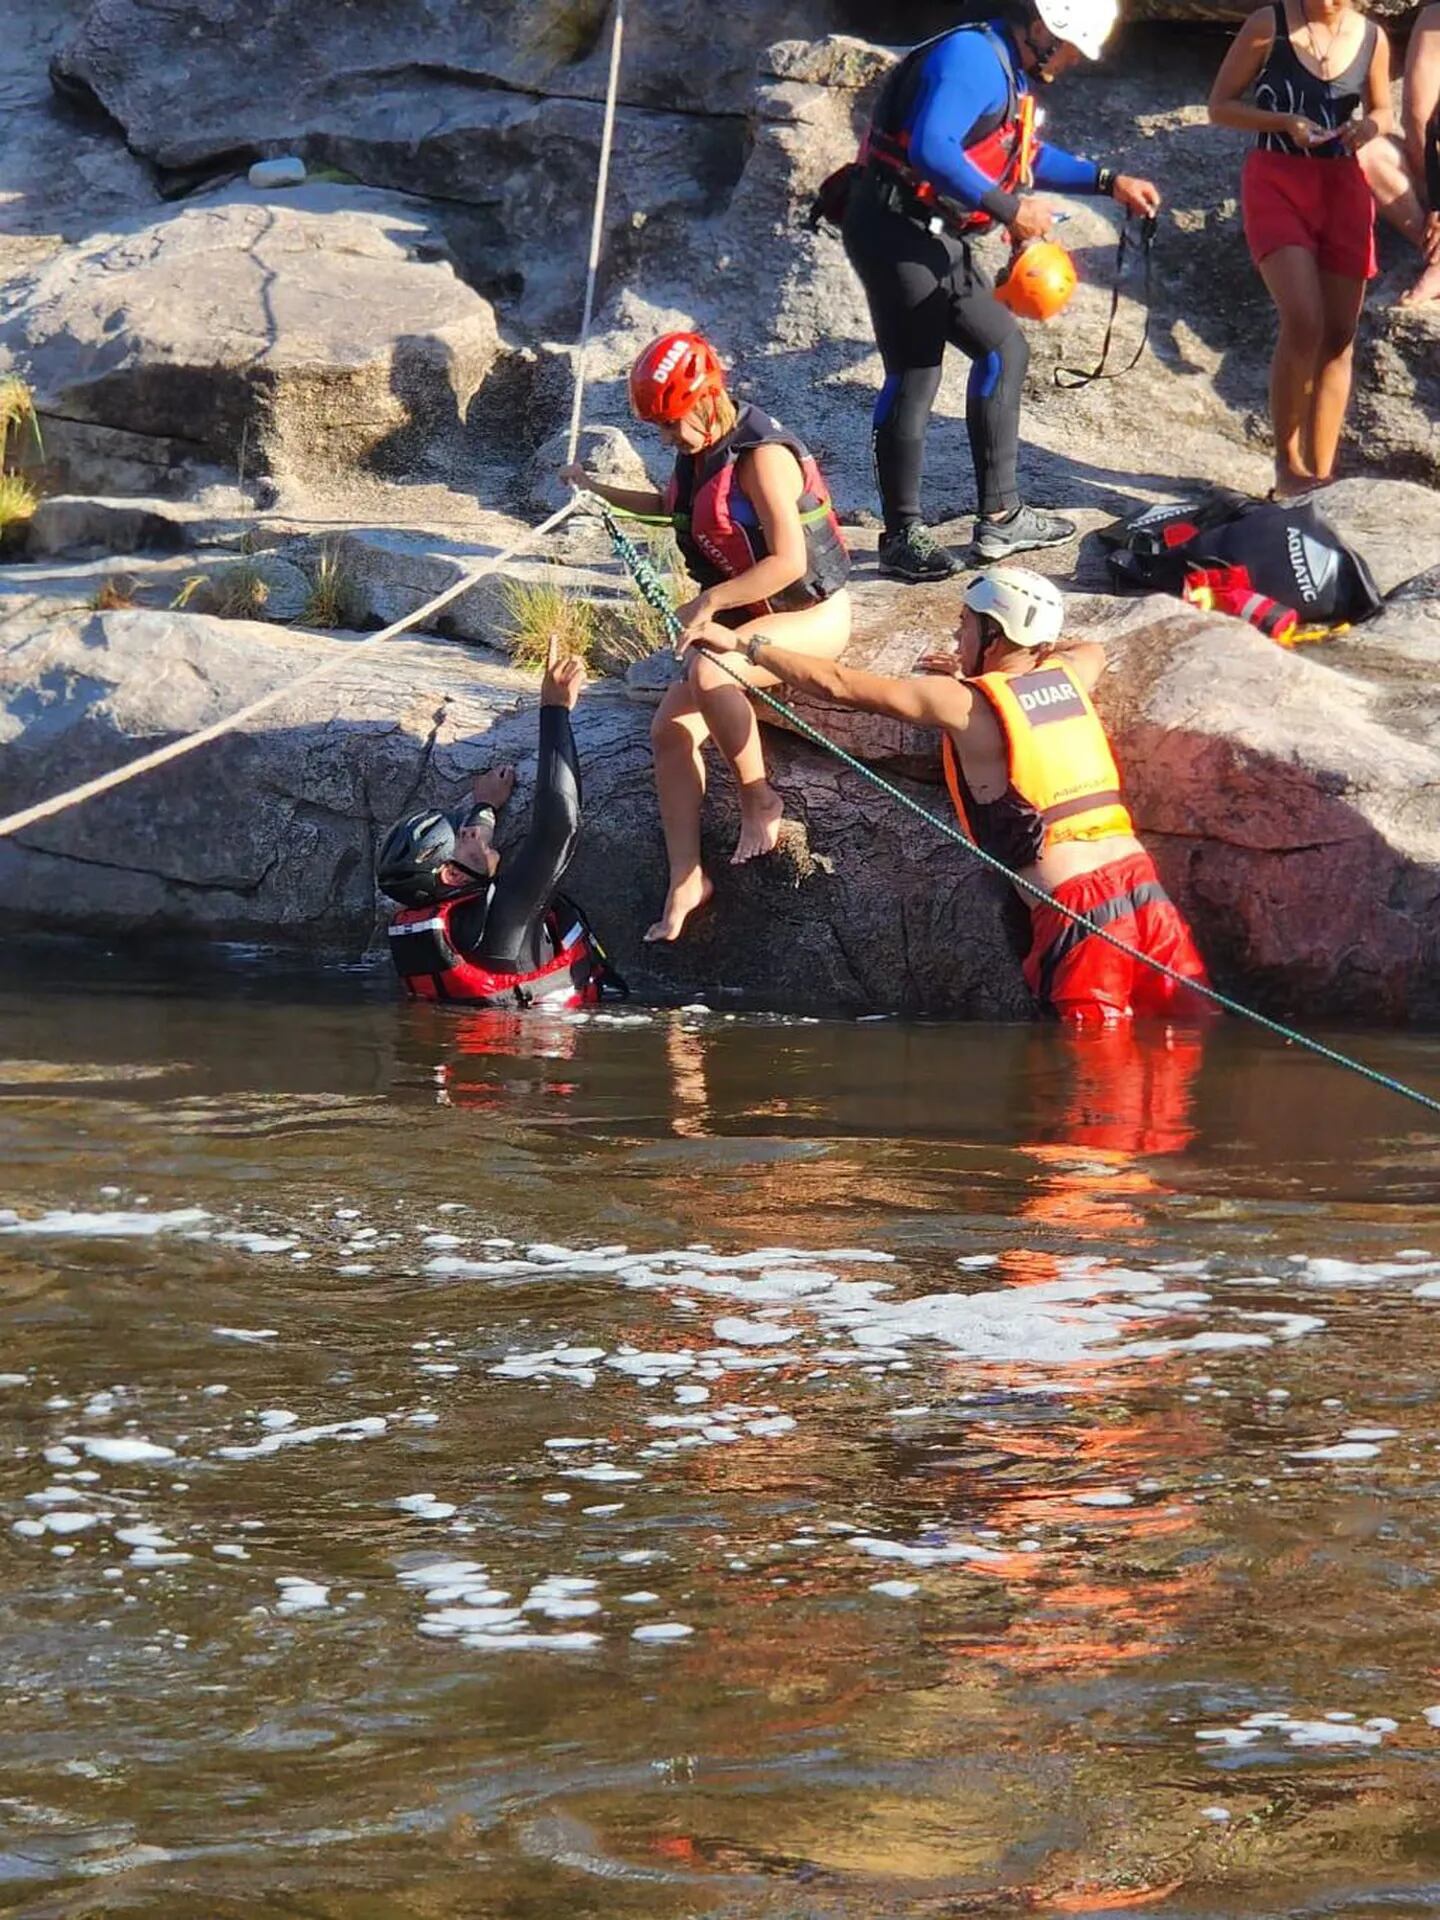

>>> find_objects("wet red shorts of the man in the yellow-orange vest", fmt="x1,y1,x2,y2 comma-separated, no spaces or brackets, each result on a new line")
1025,852,1210,1020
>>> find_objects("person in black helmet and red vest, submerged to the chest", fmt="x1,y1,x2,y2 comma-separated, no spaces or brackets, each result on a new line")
374,639,624,1006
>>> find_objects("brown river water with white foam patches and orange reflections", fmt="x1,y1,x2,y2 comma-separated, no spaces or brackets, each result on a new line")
0,954,1440,1920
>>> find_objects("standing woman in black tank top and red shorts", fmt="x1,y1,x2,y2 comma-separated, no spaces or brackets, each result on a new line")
1210,0,1392,497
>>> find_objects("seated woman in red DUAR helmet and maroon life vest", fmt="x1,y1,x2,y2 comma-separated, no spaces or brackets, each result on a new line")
561,332,851,941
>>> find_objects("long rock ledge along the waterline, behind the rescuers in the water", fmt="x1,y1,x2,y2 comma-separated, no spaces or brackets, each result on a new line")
0,570,1440,1023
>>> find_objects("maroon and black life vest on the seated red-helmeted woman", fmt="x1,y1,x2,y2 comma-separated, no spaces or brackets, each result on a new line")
664,407,851,614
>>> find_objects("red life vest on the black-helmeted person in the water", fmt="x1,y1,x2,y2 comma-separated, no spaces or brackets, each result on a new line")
390,893,626,1010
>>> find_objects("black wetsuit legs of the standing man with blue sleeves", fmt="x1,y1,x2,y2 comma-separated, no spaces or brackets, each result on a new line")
845,177,1029,534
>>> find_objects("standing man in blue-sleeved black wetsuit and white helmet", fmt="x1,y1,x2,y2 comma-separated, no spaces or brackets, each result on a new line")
845,0,1160,580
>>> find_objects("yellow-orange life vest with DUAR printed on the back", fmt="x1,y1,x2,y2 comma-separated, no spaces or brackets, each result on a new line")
941,659,1135,864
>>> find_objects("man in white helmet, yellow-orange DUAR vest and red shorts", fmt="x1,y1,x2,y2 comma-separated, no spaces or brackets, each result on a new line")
697,566,1206,1021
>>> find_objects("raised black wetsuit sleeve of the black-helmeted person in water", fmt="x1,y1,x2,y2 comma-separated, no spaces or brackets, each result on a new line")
472,707,580,973
